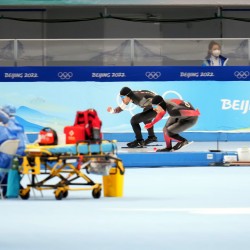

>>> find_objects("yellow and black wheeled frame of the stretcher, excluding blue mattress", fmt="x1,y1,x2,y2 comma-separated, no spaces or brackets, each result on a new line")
20,140,125,200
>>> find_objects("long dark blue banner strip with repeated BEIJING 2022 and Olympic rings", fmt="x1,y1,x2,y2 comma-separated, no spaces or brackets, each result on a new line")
0,66,250,82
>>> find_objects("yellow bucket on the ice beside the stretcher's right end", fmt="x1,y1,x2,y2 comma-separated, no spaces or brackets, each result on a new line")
103,164,124,197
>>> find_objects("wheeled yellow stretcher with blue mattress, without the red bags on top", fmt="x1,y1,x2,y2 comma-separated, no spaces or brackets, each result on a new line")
20,140,124,200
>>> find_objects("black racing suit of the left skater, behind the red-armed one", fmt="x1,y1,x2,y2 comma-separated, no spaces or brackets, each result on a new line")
114,90,157,140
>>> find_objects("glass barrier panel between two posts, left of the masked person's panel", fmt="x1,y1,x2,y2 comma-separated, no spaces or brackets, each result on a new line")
17,39,131,66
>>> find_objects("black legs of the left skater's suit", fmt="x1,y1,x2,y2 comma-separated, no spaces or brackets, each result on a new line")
130,108,157,140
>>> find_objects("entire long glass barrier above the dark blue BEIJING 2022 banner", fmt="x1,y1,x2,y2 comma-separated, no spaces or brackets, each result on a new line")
0,38,250,66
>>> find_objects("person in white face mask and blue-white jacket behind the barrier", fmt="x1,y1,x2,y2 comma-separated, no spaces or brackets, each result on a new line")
202,41,228,66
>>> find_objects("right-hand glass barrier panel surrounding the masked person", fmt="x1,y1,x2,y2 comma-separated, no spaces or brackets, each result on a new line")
134,39,249,66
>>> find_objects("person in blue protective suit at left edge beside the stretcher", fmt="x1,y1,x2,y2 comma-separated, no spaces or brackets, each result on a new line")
0,105,28,196
